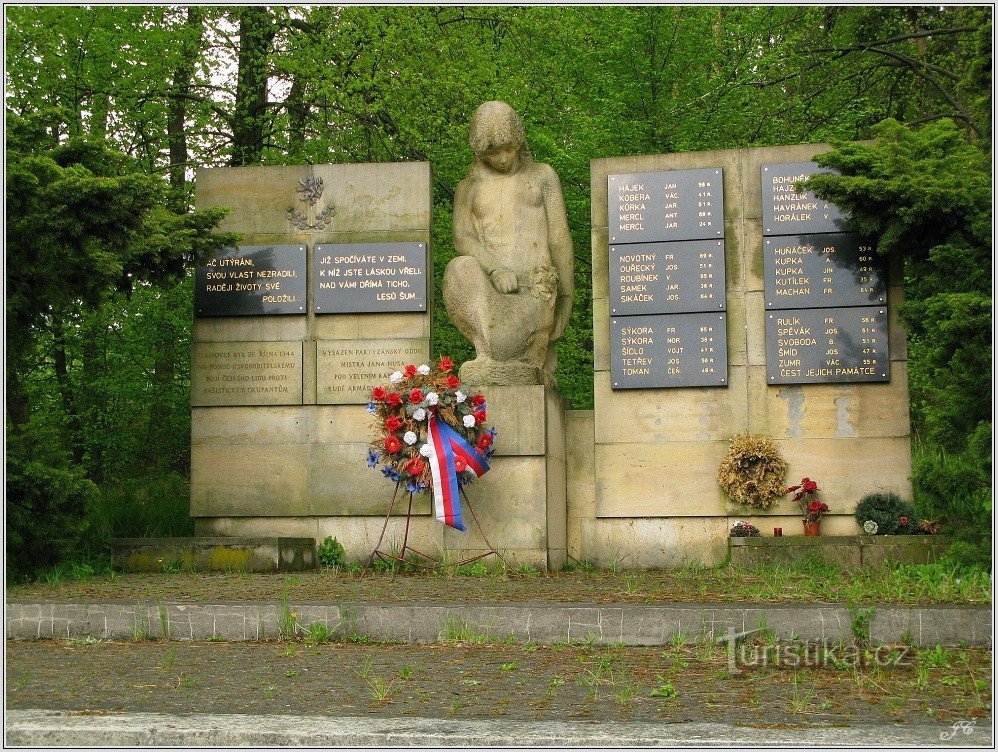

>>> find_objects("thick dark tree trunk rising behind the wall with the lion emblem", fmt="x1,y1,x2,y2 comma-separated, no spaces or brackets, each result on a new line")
231,6,277,167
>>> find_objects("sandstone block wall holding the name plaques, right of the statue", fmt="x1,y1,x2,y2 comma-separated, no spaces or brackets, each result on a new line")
584,144,911,566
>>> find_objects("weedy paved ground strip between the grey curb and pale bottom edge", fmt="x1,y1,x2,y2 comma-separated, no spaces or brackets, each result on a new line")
6,639,992,728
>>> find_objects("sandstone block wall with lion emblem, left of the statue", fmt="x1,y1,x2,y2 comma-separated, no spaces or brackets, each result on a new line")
191,163,440,556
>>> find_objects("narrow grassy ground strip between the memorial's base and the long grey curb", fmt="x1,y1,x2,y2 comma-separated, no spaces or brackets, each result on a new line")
7,569,991,605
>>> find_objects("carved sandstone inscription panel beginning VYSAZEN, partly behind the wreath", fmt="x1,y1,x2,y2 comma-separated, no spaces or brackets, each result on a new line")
315,338,430,405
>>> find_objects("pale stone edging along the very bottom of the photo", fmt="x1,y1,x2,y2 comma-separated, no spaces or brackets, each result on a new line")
5,710,993,748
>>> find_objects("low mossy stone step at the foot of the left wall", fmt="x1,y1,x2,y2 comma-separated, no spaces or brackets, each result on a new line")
111,537,316,572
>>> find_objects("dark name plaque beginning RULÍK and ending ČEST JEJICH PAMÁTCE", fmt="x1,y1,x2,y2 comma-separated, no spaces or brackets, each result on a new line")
766,306,891,384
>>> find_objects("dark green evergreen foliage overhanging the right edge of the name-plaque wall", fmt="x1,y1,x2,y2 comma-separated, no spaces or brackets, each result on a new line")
810,120,993,559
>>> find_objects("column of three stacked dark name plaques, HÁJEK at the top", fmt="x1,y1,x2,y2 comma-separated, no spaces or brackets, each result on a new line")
607,168,728,389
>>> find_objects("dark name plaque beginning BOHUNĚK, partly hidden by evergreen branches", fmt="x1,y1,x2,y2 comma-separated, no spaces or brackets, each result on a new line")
762,162,845,235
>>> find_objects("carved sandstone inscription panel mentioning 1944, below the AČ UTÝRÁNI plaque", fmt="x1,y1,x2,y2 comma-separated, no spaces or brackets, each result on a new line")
191,342,303,407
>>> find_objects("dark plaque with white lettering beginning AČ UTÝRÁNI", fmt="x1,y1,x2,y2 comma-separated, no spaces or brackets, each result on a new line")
194,245,305,316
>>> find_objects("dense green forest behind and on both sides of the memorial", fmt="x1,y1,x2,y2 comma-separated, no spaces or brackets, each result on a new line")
5,6,992,576
